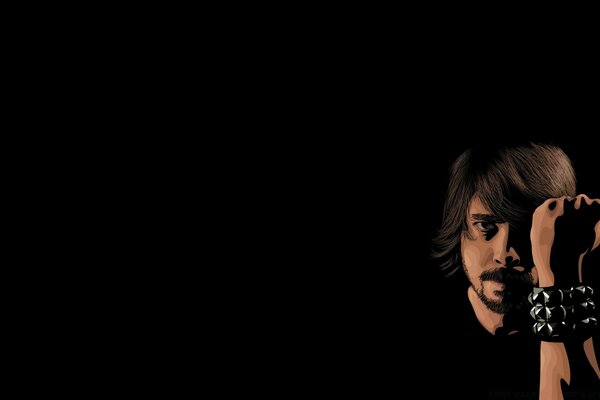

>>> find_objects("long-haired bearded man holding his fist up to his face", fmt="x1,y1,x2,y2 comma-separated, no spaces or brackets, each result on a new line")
433,144,600,399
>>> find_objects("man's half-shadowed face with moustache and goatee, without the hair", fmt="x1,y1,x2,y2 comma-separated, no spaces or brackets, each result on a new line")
461,197,537,313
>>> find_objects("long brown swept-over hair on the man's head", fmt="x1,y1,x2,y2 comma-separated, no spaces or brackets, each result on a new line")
432,143,576,275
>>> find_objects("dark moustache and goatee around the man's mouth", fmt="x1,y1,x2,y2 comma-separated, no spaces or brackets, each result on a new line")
475,268,533,314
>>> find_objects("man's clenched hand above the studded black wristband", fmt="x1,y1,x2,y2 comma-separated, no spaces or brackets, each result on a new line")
531,194,600,287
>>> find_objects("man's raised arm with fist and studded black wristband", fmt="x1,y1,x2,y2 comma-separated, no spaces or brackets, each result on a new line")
531,195,600,400
